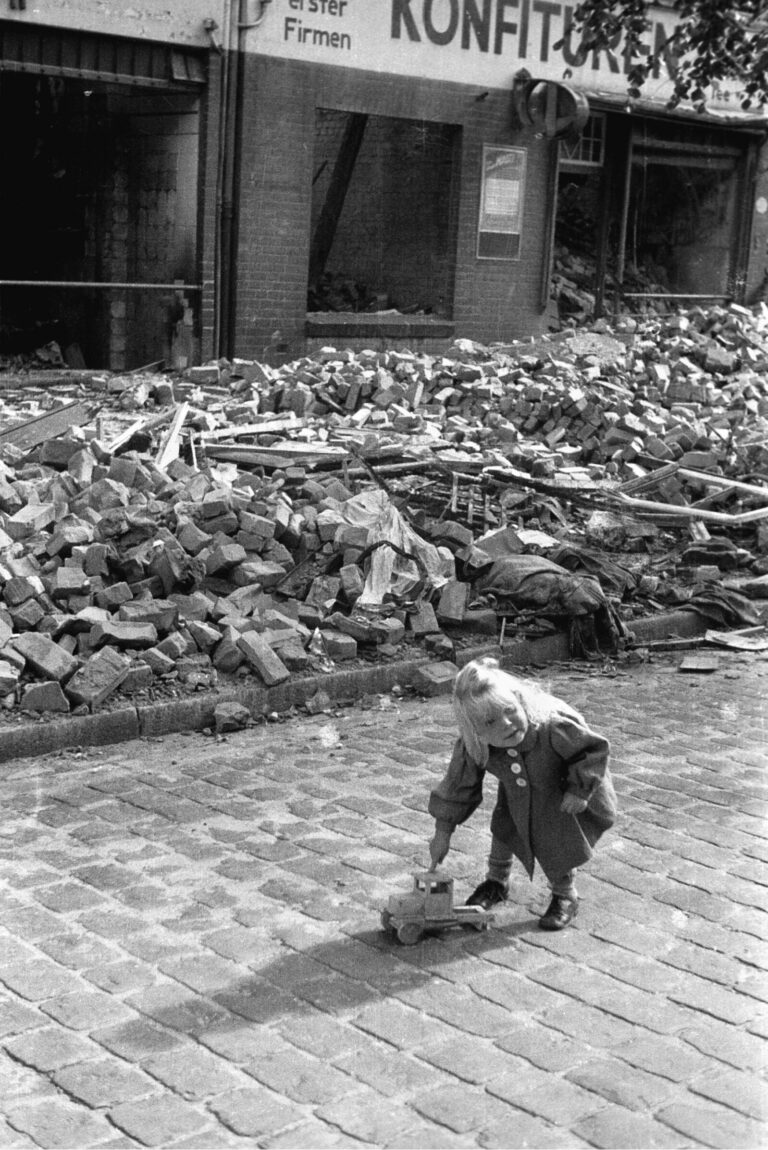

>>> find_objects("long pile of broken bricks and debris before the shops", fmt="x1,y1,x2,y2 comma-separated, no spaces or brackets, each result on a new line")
0,296,768,712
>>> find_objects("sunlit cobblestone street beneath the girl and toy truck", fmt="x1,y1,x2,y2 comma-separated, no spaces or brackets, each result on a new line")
0,656,768,1150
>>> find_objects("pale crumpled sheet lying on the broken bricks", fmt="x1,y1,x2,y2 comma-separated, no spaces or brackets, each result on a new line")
339,490,455,610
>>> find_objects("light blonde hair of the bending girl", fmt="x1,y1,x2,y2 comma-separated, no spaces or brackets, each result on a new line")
453,656,556,766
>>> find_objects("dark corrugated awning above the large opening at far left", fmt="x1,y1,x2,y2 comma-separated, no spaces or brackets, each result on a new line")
0,23,206,87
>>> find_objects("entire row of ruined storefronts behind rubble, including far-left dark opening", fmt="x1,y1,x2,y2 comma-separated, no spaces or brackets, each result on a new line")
0,0,768,370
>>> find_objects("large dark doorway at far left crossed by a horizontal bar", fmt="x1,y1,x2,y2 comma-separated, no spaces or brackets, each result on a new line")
0,71,199,369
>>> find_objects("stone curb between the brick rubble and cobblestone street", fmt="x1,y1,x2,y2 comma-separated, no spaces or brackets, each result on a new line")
0,611,711,762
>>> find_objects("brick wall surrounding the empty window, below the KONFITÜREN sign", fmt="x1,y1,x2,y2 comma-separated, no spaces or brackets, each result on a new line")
231,56,552,359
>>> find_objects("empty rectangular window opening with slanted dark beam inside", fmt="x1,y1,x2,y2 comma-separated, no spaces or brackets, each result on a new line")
307,108,460,319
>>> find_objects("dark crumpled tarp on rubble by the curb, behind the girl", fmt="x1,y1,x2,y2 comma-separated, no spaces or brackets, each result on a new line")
475,555,624,656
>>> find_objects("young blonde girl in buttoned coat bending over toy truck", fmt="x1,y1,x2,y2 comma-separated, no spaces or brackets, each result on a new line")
429,658,616,930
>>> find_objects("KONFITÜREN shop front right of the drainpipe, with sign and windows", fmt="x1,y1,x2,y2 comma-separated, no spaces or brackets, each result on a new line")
229,0,766,359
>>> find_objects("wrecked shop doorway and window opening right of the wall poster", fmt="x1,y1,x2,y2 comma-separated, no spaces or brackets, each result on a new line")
550,114,750,328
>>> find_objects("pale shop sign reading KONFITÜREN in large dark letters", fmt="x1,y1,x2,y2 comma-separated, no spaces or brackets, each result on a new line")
255,0,734,107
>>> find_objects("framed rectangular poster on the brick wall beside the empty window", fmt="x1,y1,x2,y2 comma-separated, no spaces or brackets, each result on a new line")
477,144,527,260
